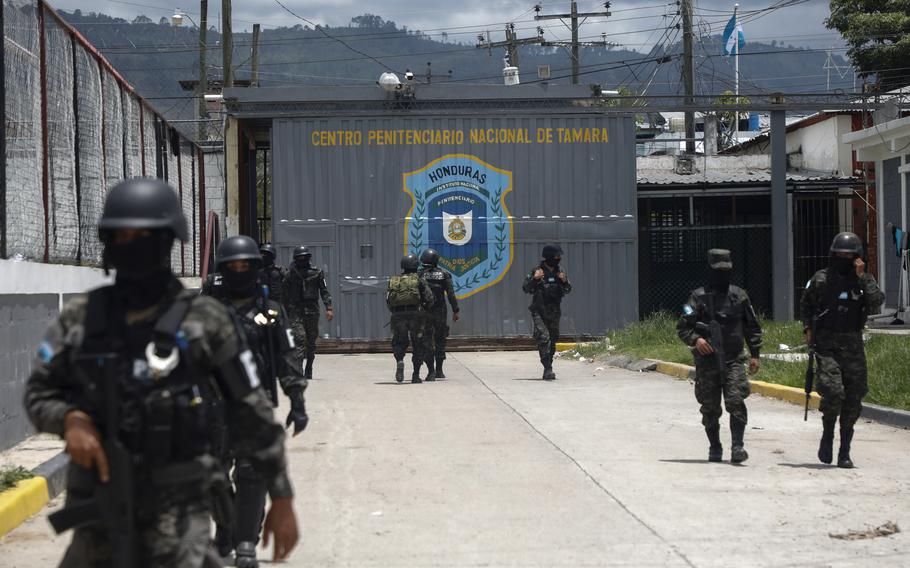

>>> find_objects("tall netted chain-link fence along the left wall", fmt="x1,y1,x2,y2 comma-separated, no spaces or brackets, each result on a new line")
0,0,206,276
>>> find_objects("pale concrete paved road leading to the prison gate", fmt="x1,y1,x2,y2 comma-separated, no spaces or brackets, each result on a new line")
0,353,910,568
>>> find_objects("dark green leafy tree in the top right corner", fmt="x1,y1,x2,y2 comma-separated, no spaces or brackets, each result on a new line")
825,0,910,91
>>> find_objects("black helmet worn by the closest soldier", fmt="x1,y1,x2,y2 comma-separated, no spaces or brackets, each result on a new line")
98,178,189,241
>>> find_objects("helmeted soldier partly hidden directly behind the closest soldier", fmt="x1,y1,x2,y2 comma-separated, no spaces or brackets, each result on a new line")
205,236,309,568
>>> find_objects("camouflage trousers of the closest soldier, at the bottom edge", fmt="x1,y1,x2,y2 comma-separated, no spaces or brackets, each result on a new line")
60,503,223,568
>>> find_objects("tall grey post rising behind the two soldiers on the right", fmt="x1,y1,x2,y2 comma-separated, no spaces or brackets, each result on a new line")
771,109,793,321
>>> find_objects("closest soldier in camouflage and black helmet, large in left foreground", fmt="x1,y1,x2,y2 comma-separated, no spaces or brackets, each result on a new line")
25,179,297,568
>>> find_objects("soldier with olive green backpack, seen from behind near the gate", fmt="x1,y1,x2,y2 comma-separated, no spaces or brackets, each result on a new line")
386,253,436,383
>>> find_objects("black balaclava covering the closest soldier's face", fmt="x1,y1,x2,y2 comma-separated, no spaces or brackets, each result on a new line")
104,232,174,310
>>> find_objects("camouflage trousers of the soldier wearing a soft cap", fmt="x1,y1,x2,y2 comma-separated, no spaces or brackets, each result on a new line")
695,352,751,427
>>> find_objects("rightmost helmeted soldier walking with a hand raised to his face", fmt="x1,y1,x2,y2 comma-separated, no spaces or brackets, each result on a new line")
800,233,885,468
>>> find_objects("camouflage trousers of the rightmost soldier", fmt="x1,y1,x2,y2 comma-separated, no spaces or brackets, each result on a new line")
815,333,869,427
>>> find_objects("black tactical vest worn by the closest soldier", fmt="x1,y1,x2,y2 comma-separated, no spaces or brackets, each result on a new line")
77,287,214,468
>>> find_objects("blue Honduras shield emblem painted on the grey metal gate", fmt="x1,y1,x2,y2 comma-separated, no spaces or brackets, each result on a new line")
404,154,513,298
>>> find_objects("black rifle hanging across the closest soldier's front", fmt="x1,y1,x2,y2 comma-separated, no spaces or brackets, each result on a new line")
49,353,139,567
